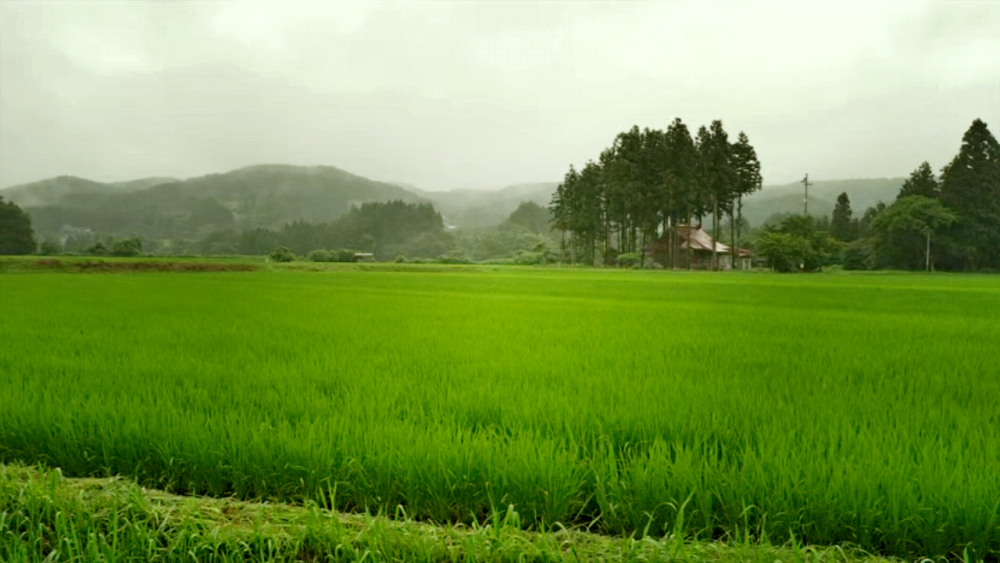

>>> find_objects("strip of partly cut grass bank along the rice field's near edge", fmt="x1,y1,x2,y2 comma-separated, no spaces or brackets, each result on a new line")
0,465,900,563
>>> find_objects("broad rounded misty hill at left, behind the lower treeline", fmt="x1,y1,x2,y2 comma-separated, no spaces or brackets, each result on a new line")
0,165,426,238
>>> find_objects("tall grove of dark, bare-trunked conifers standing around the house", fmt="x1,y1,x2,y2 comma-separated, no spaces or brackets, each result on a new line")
550,119,762,264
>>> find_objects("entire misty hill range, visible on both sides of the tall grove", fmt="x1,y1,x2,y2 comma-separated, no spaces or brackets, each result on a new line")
0,164,904,242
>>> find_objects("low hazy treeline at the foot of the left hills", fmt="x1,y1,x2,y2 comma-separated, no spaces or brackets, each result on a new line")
9,201,565,264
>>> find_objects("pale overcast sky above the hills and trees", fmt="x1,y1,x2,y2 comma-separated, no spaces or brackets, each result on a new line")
0,0,1000,190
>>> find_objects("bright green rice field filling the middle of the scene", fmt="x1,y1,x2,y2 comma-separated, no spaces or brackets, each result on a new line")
0,265,1000,560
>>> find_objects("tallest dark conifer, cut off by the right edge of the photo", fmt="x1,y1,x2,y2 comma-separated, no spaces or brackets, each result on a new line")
941,119,1000,269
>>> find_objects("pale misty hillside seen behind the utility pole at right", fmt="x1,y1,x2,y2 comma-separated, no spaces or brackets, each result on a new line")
743,178,906,227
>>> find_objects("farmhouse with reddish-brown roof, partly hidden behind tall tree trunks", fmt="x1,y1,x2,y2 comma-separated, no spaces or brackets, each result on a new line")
646,225,752,270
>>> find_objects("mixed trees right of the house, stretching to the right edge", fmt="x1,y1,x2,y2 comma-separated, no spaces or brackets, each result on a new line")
753,119,1000,271
